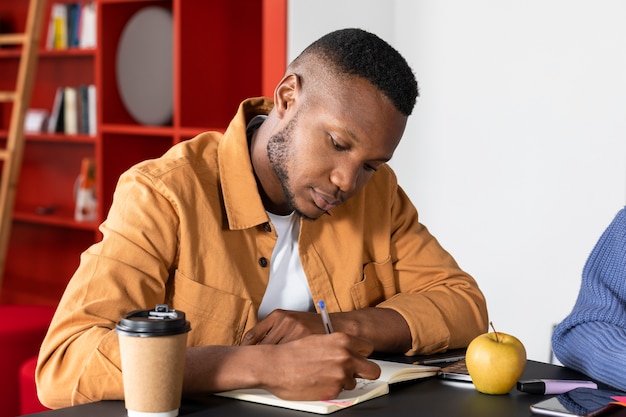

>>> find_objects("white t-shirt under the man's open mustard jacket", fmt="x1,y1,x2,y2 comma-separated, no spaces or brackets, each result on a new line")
259,212,315,320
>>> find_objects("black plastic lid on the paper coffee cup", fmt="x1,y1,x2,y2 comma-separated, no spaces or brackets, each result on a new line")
116,304,191,337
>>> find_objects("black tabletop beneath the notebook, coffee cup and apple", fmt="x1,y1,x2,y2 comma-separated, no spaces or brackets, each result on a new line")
19,357,626,417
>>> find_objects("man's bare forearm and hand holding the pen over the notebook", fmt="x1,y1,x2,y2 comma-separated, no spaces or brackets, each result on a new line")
184,332,380,400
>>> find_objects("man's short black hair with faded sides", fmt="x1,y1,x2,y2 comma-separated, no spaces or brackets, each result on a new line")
296,29,419,116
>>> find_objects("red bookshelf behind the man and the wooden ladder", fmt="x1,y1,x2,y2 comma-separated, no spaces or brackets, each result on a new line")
0,0,287,305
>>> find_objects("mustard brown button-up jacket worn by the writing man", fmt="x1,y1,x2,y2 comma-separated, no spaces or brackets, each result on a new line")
36,98,487,408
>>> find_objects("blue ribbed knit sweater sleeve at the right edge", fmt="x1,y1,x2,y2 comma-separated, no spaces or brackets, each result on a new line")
552,208,626,390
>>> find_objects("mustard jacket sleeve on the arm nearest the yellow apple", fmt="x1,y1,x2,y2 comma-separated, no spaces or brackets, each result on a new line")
370,167,488,355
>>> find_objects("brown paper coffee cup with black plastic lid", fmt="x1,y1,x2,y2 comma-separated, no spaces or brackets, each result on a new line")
116,304,191,417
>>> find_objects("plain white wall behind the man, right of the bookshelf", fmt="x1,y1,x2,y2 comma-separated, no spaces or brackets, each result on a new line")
289,0,626,361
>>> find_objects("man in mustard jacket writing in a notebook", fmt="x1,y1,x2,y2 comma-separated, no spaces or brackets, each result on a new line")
36,29,487,407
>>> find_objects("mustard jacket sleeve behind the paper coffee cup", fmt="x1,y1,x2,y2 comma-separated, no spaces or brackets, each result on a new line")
36,167,177,408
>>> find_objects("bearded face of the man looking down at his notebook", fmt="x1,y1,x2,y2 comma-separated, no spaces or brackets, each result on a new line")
267,79,406,223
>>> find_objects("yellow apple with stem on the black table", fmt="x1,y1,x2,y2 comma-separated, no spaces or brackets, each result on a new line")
465,325,526,394
